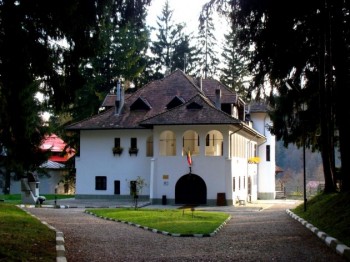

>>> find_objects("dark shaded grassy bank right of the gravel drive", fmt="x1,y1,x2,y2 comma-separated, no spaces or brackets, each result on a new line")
291,193,350,247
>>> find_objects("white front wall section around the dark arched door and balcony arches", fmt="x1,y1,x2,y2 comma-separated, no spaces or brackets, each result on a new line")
154,126,230,204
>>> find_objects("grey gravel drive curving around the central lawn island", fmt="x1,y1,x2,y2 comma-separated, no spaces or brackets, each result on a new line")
27,203,346,262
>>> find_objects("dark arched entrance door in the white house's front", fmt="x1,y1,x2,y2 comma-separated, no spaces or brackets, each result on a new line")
175,174,207,205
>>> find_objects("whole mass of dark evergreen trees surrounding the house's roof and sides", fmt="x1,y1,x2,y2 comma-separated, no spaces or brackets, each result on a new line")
0,0,350,192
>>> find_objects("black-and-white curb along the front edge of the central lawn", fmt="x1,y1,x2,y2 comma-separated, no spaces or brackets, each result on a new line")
84,210,231,237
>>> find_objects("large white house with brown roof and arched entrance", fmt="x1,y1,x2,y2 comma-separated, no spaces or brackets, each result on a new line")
67,70,275,205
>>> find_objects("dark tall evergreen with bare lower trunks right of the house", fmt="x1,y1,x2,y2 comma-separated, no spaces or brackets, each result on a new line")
206,0,350,192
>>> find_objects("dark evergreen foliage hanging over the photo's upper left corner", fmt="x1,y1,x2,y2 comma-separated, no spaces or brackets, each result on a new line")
0,0,150,190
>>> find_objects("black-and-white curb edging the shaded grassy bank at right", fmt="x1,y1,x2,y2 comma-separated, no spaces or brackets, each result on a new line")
286,209,350,261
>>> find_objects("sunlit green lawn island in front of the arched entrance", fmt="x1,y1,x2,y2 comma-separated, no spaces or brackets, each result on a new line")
87,208,229,235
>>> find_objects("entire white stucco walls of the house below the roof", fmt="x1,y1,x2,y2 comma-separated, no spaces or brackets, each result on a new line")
76,121,274,203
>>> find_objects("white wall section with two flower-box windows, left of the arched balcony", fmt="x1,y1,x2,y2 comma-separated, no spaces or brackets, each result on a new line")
76,130,152,195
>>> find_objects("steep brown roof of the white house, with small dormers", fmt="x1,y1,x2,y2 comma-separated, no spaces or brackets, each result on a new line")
67,70,258,130
